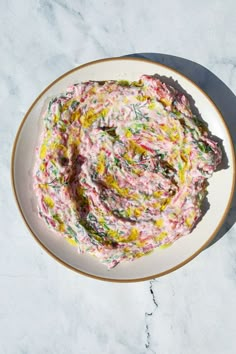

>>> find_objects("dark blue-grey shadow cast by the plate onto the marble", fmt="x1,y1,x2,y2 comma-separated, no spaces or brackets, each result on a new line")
127,53,236,248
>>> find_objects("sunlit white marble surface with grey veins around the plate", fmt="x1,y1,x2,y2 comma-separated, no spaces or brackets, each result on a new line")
0,0,236,354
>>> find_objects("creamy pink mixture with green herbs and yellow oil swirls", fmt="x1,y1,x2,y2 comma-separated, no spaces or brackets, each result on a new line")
35,75,222,268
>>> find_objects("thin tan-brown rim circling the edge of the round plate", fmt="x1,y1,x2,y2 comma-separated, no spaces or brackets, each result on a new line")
10,57,236,283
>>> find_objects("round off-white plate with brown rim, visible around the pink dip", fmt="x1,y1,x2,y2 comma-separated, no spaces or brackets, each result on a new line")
12,58,235,281
